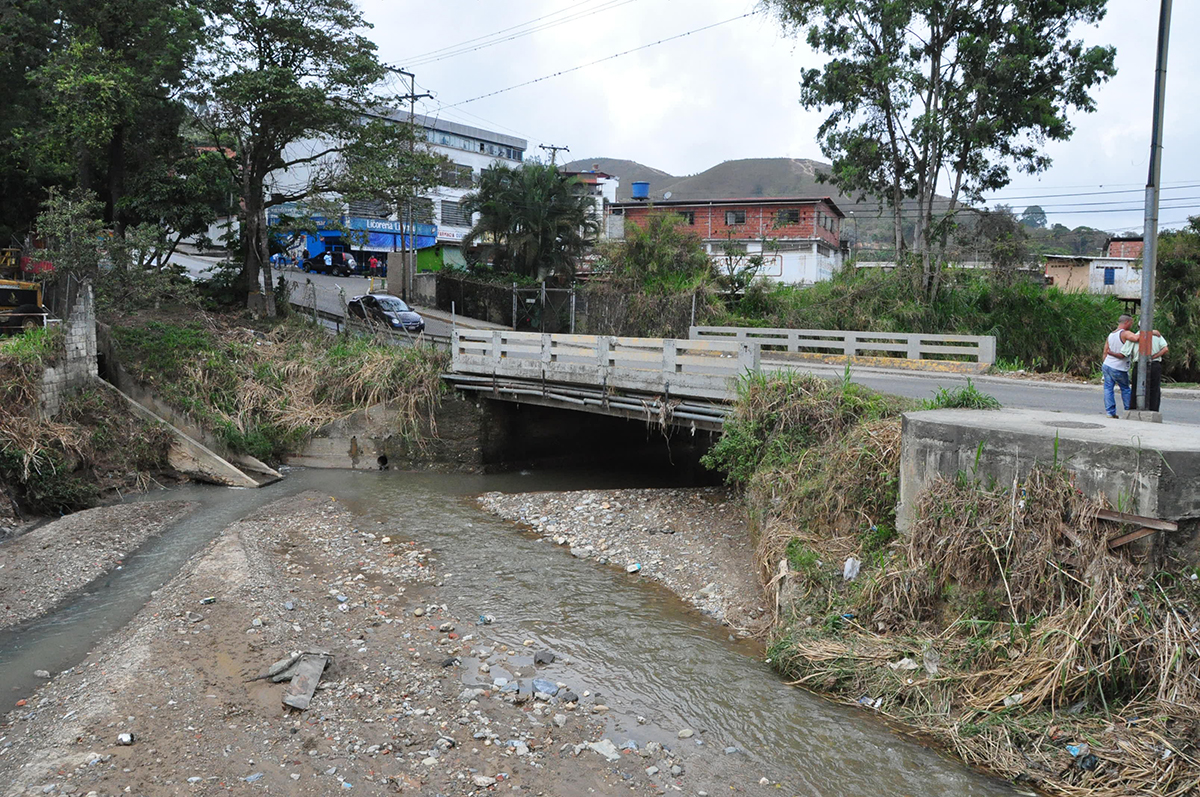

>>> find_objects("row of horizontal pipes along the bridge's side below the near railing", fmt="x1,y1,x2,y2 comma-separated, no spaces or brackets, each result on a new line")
443,373,730,432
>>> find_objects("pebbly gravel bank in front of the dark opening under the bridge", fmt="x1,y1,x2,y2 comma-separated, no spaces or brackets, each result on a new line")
479,487,767,635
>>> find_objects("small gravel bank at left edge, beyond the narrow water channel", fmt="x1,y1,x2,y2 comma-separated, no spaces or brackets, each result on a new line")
0,501,194,628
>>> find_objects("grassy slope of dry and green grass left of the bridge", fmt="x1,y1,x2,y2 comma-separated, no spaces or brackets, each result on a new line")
113,318,446,462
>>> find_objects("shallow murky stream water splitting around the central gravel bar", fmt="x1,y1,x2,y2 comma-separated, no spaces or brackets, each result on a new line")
0,471,1014,797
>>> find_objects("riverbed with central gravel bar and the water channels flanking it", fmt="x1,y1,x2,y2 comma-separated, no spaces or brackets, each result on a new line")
0,471,1013,796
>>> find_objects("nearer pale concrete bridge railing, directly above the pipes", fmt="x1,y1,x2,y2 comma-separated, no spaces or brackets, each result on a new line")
451,329,758,401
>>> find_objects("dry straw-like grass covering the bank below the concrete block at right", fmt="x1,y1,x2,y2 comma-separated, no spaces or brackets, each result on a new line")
773,471,1200,797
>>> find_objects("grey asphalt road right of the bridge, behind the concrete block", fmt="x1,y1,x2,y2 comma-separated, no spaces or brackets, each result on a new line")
782,366,1200,425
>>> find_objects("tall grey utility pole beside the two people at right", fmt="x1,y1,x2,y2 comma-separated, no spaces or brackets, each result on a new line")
1134,0,1171,420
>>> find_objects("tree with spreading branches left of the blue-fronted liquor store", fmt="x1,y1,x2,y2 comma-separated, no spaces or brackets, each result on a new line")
190,0,398,312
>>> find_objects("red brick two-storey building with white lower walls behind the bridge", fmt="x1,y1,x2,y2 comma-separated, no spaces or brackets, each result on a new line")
607,197,845,284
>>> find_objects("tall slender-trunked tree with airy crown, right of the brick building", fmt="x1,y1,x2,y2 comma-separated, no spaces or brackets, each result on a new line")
767,0,1116,294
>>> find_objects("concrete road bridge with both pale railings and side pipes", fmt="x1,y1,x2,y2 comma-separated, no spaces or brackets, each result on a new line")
446,326,996,431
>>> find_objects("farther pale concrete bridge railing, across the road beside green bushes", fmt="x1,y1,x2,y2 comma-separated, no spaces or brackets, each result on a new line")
689,326,996,371
